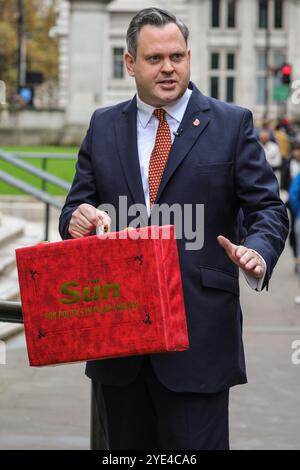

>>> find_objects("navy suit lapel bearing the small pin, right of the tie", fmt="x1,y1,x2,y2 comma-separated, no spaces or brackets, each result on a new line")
155,86,210,203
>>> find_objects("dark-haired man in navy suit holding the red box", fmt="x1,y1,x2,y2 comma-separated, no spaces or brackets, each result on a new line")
60,8,288,450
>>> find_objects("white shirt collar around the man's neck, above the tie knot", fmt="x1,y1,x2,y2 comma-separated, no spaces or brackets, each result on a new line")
136,88,192,127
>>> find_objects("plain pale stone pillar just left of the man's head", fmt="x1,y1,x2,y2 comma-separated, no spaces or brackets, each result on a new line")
66,0,111,127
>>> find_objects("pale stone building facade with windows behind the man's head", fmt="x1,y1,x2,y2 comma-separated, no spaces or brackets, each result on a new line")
59,0,300,125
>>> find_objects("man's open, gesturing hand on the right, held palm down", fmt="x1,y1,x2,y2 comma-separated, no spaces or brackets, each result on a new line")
217,235,265,279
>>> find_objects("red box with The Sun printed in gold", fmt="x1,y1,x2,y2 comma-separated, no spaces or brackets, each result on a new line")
16,226,189,366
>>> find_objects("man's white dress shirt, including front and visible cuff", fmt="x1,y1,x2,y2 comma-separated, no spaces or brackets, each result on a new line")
136,88,266,290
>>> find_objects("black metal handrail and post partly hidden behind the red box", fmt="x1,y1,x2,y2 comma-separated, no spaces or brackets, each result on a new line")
0,300,107,450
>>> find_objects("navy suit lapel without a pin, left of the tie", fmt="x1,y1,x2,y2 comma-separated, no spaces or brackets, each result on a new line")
115,97,145,205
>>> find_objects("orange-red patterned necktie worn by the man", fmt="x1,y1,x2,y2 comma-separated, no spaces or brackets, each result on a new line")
149,108,172,207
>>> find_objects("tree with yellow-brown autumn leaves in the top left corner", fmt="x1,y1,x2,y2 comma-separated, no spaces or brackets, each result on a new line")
0,0,58,103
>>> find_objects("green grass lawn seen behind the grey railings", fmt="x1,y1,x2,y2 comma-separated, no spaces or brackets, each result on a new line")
0,146,78,196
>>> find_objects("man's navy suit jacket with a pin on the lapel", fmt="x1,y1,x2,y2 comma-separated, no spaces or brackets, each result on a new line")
60,83,288,393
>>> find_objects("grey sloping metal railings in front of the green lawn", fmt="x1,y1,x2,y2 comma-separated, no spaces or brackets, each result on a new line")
0,150,74,240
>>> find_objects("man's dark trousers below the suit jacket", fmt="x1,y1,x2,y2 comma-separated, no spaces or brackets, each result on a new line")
93,356,229,450
